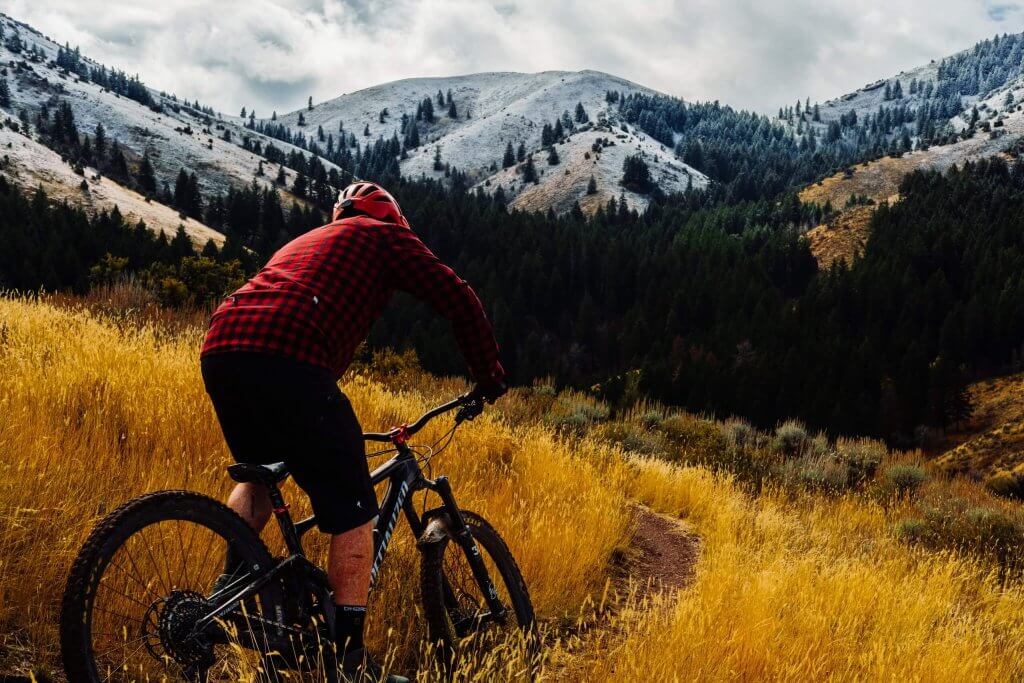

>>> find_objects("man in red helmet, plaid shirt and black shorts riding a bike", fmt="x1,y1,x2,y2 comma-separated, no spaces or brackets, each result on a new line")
201,181,505,683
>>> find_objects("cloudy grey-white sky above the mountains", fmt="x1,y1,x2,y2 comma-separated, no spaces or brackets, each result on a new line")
8,0,1024,115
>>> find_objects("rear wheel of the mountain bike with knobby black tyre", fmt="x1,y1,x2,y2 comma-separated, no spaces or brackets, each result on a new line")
60,490,282,683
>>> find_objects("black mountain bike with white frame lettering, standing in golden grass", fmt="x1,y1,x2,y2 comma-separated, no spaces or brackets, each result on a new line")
60,394,539,683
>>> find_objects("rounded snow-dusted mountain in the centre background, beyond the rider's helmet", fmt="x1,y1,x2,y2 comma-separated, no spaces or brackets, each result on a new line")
278,71,708,212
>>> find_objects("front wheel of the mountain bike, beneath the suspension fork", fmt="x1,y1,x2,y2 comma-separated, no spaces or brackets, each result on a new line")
420,510,540,670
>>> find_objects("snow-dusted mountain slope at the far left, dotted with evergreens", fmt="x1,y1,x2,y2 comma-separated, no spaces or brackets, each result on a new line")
0,14,331,244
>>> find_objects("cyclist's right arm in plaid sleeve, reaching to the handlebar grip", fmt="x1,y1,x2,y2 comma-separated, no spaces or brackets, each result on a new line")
388,228,505,387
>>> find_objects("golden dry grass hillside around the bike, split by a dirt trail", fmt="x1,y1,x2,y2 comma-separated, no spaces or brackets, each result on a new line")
0,298,1024,681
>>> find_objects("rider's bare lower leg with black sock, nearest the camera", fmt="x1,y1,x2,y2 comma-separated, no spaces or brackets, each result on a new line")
328,520,374,657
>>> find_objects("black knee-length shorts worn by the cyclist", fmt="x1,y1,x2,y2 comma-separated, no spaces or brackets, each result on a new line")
202,352,378,533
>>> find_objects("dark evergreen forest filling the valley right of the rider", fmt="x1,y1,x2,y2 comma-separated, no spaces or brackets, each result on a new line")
362,160,1024,444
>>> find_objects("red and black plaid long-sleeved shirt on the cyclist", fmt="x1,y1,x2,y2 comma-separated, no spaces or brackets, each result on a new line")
202,216,505,385
